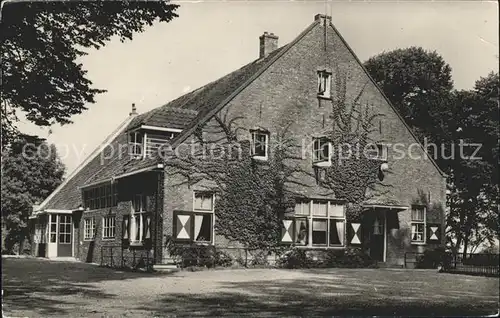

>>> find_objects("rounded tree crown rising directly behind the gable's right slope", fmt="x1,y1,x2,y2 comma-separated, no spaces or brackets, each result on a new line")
365,47,453,140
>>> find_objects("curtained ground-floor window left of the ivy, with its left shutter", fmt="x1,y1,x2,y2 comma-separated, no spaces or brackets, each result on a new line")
174,191,215,243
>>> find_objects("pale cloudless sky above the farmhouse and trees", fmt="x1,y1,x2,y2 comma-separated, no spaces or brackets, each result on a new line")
18,0,499,175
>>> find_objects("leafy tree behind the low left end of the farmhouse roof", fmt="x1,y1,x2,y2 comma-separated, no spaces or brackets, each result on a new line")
1,135,64,252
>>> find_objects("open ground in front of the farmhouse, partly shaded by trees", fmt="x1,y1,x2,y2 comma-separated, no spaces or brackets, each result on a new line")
2,258,499,317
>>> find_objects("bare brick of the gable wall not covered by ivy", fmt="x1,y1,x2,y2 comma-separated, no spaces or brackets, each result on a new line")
159,18,445,263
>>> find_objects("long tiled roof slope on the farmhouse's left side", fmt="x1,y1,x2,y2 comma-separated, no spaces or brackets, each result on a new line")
43,47,292,210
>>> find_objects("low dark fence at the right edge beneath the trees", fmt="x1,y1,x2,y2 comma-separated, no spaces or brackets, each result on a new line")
404,252,500,276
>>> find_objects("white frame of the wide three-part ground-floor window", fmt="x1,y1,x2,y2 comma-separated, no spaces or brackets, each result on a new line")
293,199,347,249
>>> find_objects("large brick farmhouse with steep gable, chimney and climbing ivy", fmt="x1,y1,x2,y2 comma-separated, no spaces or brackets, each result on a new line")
30,14,445,265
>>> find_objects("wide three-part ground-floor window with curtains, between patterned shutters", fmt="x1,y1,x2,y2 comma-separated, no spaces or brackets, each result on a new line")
285,200,345,247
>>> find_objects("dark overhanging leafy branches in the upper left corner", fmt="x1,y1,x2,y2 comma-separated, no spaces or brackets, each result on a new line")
1,1,178,149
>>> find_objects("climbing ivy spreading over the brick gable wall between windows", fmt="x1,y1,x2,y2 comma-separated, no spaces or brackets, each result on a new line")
165,64,390,250
